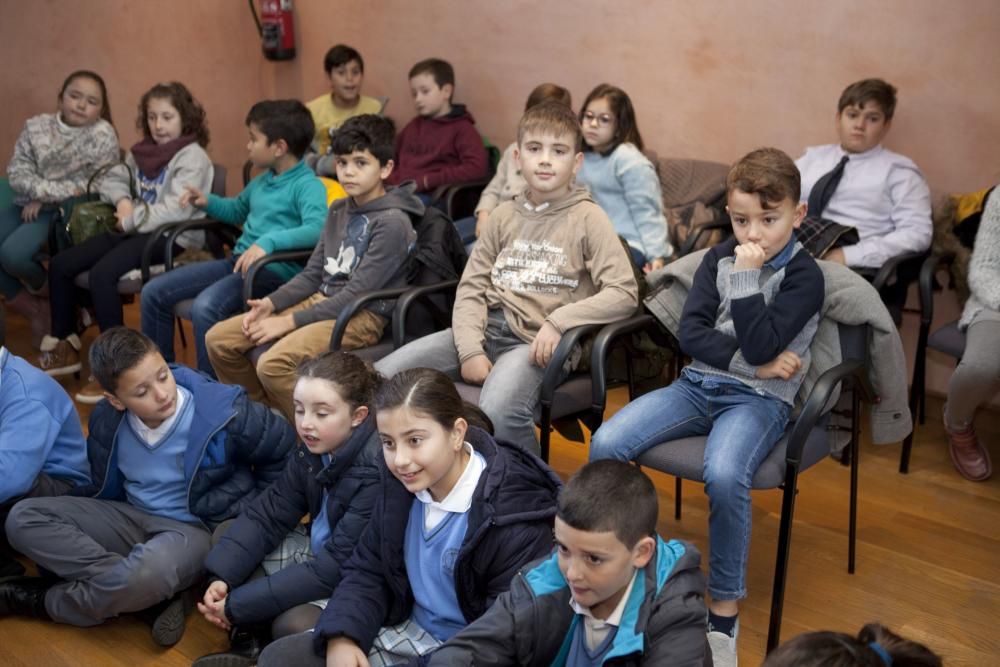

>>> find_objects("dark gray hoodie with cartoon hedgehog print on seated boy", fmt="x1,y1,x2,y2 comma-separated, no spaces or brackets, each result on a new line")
268,184,424,328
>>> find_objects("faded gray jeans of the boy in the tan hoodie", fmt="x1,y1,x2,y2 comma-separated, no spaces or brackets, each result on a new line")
375,310,569,454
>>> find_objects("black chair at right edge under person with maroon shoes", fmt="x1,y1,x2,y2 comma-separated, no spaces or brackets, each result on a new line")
899,253,965,474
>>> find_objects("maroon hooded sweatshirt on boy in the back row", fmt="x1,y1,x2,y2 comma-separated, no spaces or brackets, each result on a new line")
389,104,488,192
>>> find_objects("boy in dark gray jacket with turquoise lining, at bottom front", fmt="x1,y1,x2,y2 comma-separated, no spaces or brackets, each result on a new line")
421,460,712,667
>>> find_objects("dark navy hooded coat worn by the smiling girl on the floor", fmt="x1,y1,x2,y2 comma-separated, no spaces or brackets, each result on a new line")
314,428,562,655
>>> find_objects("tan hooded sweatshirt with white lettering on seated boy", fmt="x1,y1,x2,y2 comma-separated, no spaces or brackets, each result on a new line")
452,187,638,362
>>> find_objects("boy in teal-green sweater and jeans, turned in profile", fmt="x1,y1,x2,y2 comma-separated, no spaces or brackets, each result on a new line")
141,100,326,377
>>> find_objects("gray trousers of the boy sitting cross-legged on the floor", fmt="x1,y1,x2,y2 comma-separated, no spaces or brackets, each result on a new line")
7,496,211,627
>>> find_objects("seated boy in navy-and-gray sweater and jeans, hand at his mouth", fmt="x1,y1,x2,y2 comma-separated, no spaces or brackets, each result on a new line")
590,148,824,666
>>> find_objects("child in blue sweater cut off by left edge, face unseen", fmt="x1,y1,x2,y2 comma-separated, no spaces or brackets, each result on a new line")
0,330,90,577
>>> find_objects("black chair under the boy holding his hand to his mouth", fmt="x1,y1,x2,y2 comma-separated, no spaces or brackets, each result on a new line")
592,315,875,651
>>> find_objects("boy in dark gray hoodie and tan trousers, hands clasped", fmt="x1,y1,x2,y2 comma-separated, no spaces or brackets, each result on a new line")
205,114,424,421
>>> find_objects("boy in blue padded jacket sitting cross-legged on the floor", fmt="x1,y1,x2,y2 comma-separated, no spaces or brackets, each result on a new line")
0,327,295,646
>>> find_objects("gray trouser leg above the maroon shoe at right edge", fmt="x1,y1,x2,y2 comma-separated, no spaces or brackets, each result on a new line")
945,320,1000,430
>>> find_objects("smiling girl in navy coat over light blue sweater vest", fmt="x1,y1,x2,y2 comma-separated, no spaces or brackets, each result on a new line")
258,368,561,667
